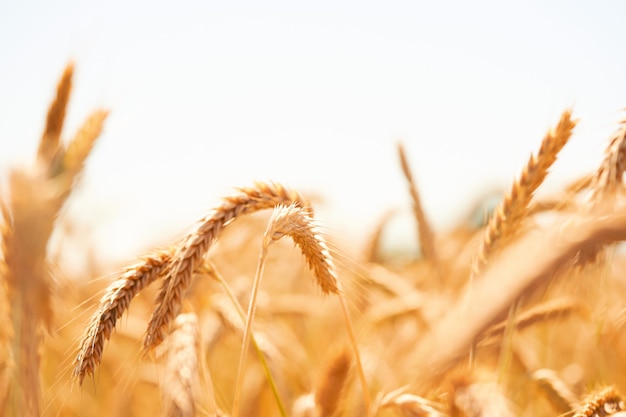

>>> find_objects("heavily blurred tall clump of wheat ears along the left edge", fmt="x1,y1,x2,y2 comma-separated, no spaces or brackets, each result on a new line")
0,63,107,416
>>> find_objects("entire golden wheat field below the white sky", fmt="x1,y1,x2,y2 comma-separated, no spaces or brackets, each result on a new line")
0,64,626,417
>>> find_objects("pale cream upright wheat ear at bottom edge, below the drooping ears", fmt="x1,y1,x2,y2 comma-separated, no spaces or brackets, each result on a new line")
162,313,200,417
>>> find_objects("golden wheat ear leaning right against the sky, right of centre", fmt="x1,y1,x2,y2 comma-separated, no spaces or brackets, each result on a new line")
472,110,576,276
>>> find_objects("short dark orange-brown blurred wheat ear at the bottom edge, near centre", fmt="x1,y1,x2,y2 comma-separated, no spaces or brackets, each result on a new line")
315,349,351,417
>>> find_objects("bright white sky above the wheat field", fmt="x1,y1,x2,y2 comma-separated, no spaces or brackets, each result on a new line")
0,0,626,259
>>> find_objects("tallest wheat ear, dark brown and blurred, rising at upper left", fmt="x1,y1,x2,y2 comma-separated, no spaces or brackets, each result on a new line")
37,62,74,166
